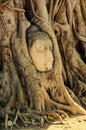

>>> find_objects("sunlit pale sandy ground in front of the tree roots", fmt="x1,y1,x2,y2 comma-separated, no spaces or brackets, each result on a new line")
0,116,86,130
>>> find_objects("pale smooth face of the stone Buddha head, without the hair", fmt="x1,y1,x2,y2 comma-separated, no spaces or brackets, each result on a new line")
29,39,54,72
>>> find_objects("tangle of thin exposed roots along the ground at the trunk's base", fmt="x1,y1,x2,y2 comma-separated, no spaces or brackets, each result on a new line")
2,105,68,129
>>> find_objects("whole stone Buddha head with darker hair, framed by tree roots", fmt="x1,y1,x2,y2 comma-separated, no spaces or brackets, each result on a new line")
28,26,54,72
